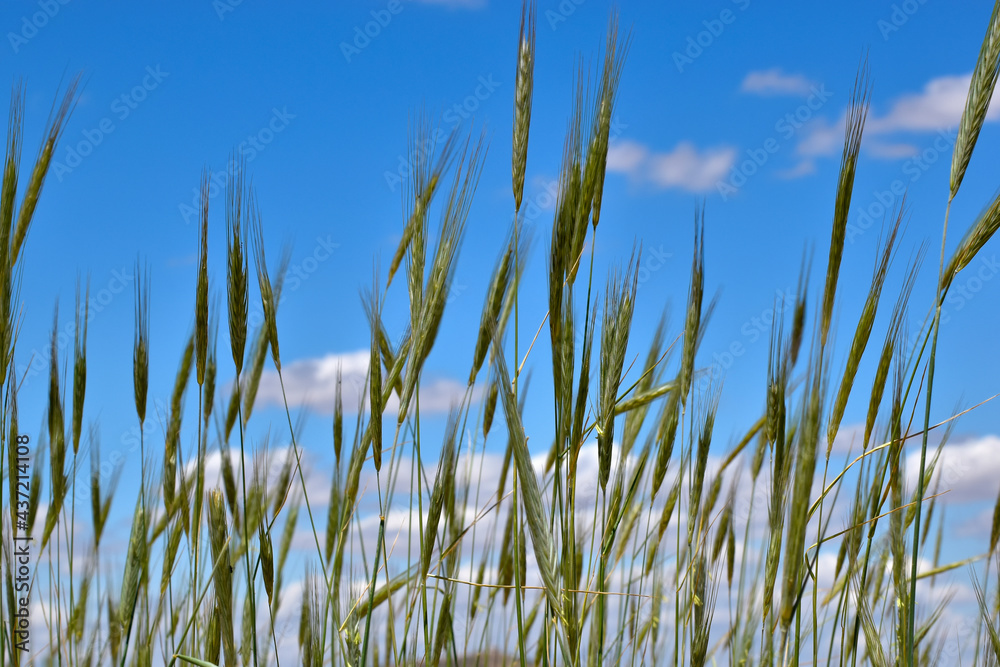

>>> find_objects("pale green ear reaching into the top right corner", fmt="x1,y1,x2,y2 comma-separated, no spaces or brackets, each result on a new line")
949,3,1000,199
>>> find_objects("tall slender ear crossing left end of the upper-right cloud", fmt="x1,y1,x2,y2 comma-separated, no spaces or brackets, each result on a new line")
820,60,871,346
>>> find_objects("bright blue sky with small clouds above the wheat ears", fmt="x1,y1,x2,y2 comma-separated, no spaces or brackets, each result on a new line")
0,0,1000,620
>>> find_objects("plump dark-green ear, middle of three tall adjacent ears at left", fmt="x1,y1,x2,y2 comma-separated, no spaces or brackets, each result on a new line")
226,158,249,377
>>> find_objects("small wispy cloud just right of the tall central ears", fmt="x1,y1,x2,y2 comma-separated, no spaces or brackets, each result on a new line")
608,141,736,192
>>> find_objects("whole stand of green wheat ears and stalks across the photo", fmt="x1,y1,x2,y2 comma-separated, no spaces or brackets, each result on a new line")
0,2,1000,666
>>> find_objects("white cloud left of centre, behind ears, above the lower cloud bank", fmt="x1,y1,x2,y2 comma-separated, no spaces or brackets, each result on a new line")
248,350,470,414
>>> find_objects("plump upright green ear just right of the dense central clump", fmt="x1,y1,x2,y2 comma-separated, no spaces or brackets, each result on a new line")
596,254,638,490
